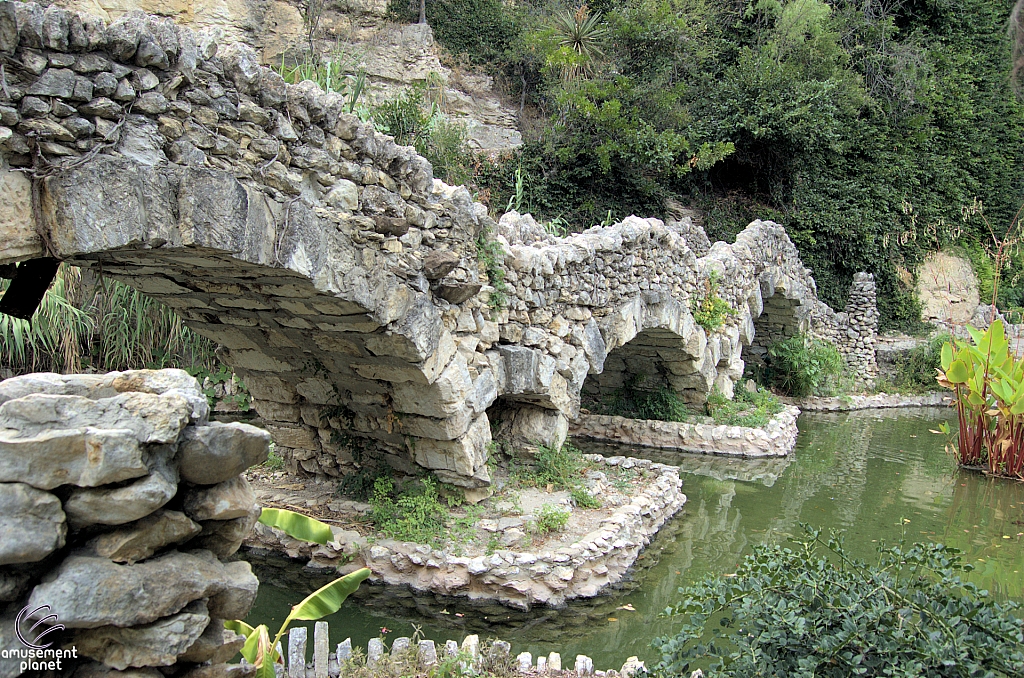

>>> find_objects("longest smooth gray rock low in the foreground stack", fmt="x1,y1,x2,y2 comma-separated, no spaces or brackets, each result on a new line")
29,551,259,629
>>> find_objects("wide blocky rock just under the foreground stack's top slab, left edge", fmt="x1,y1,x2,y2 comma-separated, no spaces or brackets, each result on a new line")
0,428,148,490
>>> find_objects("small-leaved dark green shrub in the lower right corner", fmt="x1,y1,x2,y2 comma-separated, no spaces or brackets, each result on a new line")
654,526,1024,678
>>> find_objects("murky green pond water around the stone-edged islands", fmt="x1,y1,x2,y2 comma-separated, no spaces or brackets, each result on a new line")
243,409,1024,669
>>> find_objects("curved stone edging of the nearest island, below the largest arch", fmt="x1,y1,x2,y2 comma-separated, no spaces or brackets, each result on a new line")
248,455,686,609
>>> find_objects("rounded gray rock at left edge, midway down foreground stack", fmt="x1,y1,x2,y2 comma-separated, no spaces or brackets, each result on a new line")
0,482,68,565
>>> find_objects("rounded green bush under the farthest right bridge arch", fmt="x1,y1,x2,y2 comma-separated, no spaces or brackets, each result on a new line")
764,335,846,397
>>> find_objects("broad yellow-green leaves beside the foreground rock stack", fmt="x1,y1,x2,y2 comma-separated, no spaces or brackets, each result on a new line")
224,508,371,678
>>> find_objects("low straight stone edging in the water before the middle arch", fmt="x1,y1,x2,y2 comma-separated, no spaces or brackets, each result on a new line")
569,406,800,457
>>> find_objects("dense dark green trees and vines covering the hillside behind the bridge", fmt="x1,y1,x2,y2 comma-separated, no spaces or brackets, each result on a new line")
398,0,1024,328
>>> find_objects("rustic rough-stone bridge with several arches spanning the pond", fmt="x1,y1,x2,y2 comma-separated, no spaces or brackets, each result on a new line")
0,1,877,498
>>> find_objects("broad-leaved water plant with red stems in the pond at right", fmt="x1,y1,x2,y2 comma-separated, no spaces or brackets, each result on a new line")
937,320,1024,477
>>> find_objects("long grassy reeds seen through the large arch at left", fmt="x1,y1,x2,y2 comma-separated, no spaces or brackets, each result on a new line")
0,264,217,374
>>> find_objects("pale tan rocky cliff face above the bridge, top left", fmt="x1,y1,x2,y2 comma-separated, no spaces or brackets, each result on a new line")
44,0,522,152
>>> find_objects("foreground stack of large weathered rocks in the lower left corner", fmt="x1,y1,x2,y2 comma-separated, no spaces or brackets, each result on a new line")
0,370,270,678
